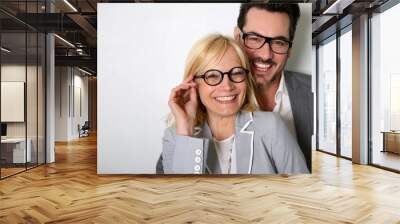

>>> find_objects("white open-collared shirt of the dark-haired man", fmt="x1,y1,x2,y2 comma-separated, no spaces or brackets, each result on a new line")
272,72,297,139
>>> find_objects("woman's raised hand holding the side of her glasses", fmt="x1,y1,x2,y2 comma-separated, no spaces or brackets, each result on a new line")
168,75,198,136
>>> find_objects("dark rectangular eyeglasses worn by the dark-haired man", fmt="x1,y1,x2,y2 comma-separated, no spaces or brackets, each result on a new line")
241,31,292,54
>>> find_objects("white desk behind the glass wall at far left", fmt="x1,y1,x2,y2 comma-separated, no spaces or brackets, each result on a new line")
1,138,32,163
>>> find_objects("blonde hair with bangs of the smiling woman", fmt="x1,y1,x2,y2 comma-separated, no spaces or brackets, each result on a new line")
167,34,258,126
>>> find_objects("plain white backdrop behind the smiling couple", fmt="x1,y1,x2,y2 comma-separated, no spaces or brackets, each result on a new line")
97,3,311,174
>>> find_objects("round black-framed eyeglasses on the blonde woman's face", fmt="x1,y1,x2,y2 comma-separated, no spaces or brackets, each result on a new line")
194,67,249,86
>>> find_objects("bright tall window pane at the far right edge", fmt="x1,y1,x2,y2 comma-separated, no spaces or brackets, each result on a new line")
370,4,400,171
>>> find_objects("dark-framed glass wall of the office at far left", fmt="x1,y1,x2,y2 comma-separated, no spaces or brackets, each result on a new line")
0,1,46,179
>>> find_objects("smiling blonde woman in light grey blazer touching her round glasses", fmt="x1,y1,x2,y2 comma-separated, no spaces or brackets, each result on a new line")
157,34,309,174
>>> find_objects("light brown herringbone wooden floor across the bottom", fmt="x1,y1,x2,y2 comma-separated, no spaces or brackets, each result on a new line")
0,134,400,224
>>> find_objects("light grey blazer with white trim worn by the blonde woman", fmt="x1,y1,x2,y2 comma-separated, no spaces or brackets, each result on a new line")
157,111,309,174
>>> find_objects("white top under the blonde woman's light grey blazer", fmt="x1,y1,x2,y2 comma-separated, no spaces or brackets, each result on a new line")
214,135,237,174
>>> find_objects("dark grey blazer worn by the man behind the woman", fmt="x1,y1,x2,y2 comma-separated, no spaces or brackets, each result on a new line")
285,71,314,170
